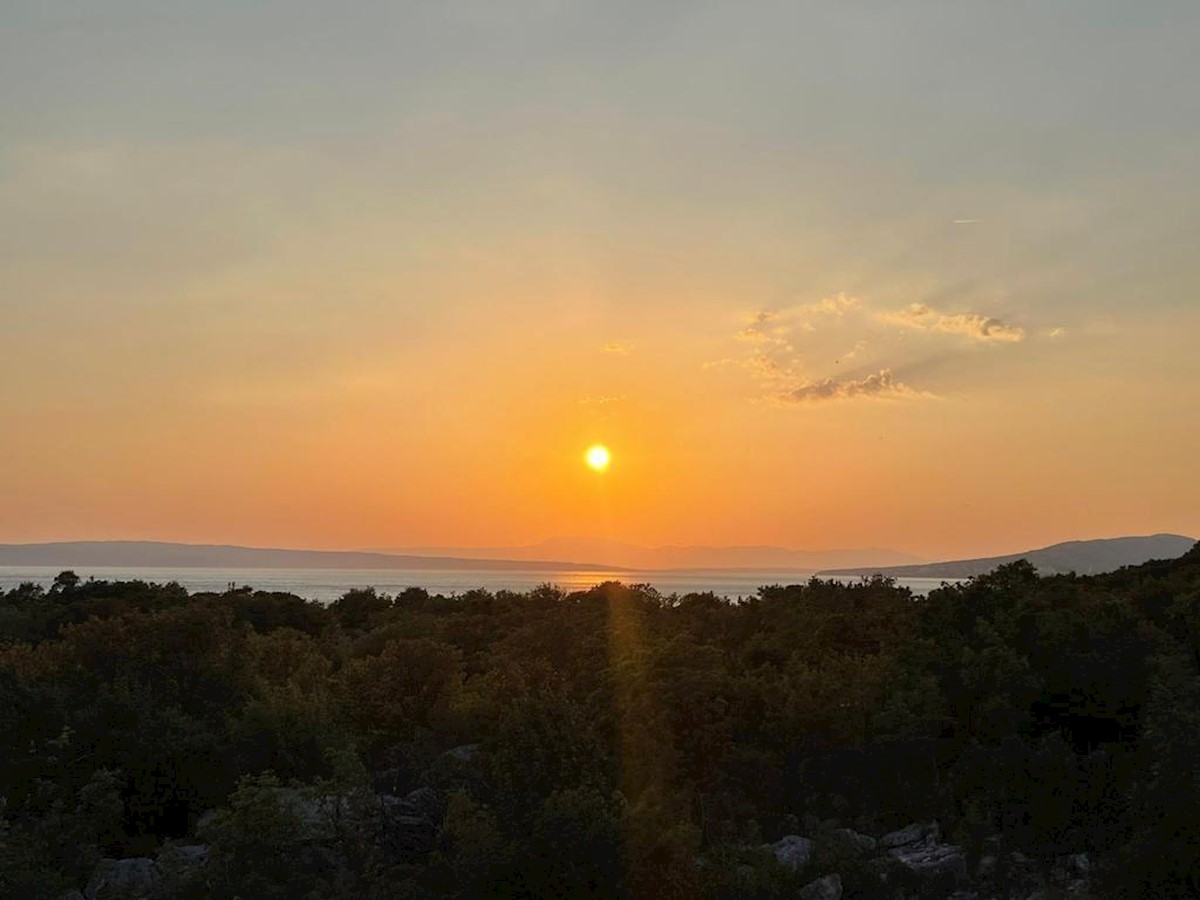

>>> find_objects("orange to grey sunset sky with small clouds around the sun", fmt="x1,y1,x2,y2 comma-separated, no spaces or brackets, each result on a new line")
0,0,1200,558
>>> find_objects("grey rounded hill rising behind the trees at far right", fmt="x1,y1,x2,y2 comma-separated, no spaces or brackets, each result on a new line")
817,534,1196,578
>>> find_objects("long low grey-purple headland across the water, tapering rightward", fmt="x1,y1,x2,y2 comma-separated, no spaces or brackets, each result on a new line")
0,541,638,571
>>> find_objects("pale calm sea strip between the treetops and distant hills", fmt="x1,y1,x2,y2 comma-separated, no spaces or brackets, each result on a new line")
0,565,954,602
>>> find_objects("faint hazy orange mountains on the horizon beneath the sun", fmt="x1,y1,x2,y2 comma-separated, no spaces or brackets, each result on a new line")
383,538,924,572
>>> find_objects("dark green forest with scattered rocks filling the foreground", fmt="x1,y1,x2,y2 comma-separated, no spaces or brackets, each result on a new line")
0,545,1200,900
